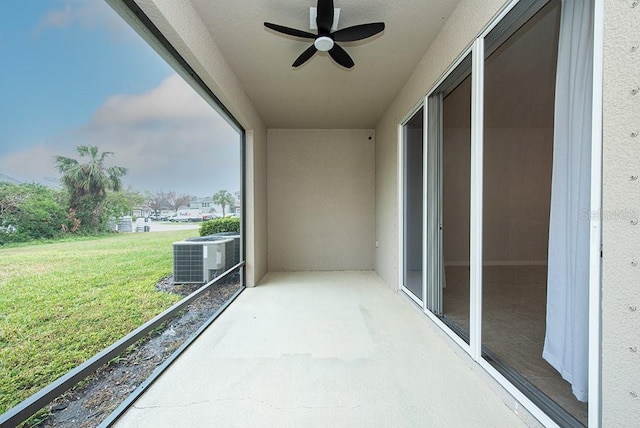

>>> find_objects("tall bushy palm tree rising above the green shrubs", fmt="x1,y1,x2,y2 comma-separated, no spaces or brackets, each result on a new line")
55,146,127,231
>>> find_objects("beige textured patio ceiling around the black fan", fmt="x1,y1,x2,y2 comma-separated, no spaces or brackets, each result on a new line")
185,0,459,128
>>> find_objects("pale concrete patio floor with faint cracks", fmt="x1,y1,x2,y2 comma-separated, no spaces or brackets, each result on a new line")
116,272,525,428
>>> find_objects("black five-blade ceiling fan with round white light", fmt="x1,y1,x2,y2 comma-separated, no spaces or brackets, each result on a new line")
264,0,384,68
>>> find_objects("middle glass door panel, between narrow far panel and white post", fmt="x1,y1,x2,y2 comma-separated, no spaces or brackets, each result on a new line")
427,56,471,343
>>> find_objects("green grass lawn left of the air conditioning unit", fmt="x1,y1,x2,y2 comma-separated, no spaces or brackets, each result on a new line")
0,230,197,413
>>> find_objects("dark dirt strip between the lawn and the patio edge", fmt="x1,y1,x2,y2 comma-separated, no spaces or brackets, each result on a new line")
38,275,240,428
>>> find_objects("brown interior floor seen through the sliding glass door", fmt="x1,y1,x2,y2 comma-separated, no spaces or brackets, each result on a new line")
444,266,588,426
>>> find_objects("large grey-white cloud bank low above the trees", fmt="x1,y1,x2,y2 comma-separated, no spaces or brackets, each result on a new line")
0,75,240,196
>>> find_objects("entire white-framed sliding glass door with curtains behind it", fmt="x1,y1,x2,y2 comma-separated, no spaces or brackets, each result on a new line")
402,0,595,426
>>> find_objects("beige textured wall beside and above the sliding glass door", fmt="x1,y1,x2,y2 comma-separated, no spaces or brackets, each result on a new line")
375,0,507,290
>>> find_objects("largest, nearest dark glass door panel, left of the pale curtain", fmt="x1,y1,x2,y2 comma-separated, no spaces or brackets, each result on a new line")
482,0,587,426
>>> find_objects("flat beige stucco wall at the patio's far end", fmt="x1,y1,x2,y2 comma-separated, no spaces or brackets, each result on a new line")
267,129,375,272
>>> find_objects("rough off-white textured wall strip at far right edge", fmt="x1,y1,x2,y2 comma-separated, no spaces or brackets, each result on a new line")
602,0,640,427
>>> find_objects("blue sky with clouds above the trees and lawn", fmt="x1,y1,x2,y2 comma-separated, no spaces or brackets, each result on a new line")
0,0,240,197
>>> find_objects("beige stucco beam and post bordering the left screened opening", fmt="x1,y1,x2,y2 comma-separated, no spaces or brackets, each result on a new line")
118,0,267,286
